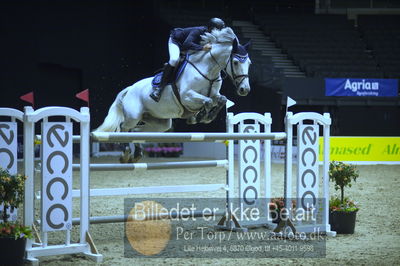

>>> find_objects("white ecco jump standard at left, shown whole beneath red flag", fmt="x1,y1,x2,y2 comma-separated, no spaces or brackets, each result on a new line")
24,107,103,263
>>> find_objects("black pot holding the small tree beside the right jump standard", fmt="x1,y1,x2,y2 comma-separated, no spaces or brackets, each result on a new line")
329,211,357,234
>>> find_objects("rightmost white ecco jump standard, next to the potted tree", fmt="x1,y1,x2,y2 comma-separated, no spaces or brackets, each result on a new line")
277,112,336,236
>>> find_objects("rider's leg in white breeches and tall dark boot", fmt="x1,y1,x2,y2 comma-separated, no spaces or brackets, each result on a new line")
150,38,180,102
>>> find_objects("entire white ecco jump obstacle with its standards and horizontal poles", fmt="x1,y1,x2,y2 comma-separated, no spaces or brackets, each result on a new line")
0,107,334,262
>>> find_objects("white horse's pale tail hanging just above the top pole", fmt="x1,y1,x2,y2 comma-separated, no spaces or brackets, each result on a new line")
94,87,129,132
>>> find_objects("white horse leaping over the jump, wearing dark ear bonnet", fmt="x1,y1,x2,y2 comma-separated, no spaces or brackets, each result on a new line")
96,27,251,160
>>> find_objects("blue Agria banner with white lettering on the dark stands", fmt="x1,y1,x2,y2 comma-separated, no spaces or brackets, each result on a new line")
325,78,398,97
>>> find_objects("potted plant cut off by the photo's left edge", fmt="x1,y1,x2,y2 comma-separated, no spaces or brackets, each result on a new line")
0,168,32,265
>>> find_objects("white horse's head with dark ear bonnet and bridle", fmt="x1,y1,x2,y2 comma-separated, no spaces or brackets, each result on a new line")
226,38,251,96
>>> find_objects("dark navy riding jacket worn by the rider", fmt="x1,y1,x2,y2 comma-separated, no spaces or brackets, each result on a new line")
171,27,207,51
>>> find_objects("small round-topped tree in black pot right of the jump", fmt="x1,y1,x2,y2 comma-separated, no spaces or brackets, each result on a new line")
329,161,359,234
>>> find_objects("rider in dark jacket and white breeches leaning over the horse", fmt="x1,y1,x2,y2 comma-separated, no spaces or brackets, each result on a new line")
150,18,225,102
